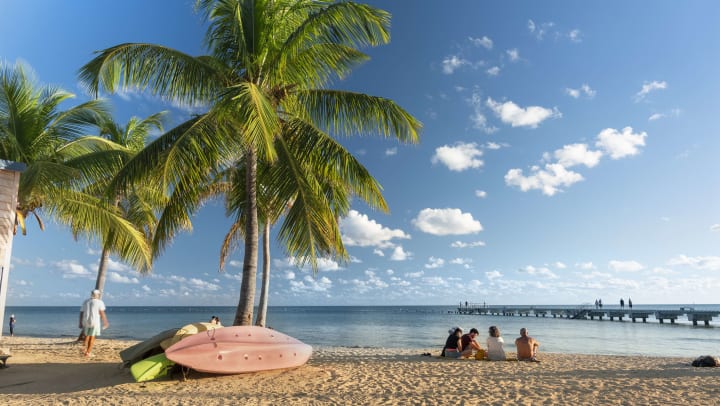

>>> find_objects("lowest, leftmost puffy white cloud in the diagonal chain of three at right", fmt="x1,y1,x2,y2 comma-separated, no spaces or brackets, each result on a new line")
505,164,583,196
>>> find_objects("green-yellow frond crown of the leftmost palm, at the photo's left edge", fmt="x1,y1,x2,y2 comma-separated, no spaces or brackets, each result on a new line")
0,64,151,267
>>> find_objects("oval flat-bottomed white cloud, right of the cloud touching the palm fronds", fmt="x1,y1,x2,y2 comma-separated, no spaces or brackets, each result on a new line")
412,208,483,235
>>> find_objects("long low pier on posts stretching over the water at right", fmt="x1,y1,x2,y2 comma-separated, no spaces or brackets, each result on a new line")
456,302,720,327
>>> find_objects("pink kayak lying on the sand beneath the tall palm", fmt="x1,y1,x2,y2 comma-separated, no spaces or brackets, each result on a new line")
165,326,312,374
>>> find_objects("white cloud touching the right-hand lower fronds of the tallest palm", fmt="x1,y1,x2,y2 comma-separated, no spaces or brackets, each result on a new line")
340,210,410,248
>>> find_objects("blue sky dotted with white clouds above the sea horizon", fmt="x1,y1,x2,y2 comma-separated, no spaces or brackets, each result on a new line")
0,0,720,306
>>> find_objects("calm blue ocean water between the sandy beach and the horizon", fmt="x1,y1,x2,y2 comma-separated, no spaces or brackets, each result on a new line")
3,305,720,357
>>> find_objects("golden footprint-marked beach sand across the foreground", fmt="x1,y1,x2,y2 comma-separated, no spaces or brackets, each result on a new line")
0,337,720,405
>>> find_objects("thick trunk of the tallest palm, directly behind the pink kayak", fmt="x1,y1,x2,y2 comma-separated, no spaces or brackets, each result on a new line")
233,147,259,326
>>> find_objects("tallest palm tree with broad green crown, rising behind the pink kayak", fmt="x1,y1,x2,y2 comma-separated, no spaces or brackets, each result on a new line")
80,0,420,325
